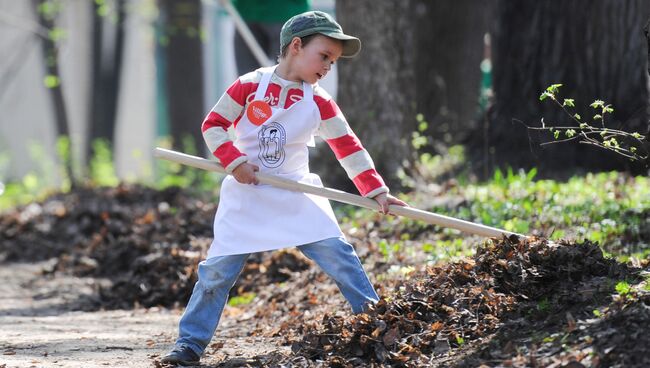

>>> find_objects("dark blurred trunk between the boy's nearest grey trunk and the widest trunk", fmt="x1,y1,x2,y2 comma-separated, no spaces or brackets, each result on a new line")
415,0,495,146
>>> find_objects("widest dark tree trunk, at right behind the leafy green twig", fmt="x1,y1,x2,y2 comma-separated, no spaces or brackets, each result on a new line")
475,0,650,175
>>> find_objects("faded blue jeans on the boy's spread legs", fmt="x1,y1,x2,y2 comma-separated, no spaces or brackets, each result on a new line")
176,238,379,355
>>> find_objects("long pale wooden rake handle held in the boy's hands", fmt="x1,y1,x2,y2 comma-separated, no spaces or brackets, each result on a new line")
154,147,524,237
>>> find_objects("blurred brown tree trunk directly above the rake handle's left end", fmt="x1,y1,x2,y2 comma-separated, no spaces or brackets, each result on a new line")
159,0,205,153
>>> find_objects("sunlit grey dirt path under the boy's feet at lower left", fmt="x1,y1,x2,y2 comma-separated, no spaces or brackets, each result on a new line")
0,262,288,368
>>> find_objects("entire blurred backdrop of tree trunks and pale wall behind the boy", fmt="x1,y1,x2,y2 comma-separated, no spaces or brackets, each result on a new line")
0,0,650,198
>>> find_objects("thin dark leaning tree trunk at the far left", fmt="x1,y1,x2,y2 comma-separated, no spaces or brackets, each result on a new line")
32,0,76,187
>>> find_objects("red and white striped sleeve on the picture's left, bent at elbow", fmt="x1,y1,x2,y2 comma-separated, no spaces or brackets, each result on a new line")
201,72,259,173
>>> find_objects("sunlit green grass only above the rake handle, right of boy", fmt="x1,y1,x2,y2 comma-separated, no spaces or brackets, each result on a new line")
402,170,650,260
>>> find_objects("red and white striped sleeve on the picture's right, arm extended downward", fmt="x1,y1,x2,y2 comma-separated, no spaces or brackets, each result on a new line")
314,87,388,198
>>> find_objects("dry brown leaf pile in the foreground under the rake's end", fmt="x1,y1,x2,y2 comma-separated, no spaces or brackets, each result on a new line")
293,237,630,366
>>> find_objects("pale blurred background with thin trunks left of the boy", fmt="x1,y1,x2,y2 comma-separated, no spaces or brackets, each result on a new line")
0,0,336,190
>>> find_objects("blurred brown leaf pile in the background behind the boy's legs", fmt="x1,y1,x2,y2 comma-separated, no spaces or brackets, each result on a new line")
0,185,308,309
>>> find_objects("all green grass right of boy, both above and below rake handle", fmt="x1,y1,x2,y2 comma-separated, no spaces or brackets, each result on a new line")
337,165,650,262
